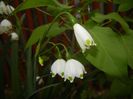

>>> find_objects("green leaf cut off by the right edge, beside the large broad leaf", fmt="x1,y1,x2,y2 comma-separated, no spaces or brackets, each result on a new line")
121,30,133,69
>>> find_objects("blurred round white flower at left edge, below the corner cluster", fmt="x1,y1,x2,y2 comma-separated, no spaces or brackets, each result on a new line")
0,19,12,34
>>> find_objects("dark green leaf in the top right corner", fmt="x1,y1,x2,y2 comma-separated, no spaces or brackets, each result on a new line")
118,0,133,11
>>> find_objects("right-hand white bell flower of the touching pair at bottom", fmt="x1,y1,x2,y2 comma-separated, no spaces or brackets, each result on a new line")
64,59,87,83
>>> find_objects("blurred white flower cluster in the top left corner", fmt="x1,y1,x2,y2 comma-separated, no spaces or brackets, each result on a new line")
0,1,15,15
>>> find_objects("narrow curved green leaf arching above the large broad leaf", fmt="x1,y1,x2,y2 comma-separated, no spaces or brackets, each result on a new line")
92,12,129,32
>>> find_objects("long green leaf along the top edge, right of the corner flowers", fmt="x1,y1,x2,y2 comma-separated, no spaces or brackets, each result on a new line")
14,0,55,13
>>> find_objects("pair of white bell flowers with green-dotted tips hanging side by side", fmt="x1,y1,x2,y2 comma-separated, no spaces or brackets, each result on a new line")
51,59,87,83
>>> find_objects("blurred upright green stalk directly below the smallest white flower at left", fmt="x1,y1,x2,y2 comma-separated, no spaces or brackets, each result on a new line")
10,41,21,99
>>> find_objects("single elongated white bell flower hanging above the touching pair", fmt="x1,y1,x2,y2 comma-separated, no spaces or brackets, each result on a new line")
73,23,96,52
